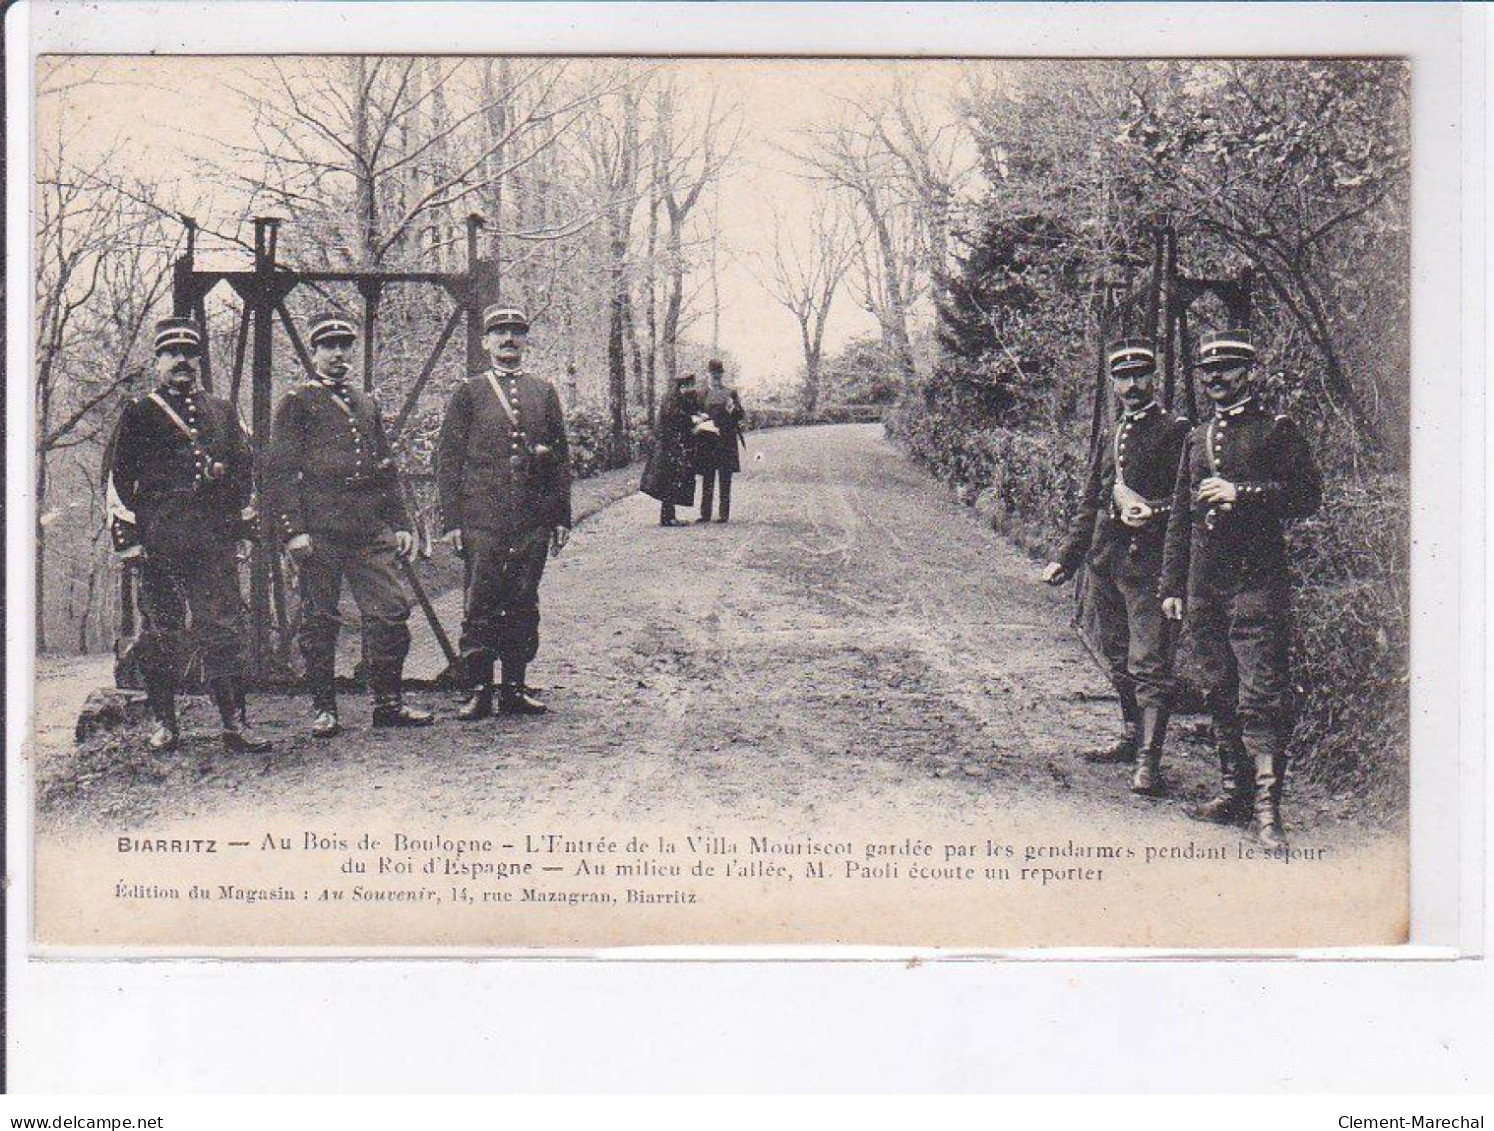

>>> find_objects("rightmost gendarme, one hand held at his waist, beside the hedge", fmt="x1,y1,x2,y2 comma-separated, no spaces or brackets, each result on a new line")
1161,330,1322,847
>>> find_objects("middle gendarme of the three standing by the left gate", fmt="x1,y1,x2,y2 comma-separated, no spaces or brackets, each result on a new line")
267,314,433,738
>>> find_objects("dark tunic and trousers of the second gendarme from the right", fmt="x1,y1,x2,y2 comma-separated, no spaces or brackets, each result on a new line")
1058,400,1188,708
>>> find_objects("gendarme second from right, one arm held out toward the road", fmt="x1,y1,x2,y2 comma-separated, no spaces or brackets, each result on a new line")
1044,338,1189,793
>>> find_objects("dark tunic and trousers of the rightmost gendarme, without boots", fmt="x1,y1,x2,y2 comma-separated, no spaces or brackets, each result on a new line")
1161,397,1322,731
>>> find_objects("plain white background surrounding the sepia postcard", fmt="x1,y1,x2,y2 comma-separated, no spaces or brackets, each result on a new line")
6,3,1494,1093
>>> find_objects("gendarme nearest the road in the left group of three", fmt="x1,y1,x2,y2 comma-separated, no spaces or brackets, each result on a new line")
436,303,571,720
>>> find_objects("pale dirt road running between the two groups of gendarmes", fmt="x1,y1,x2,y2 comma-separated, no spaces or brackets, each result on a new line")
39,426,1374,835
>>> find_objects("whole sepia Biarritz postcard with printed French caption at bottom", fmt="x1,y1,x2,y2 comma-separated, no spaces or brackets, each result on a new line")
26,54,1416,955
